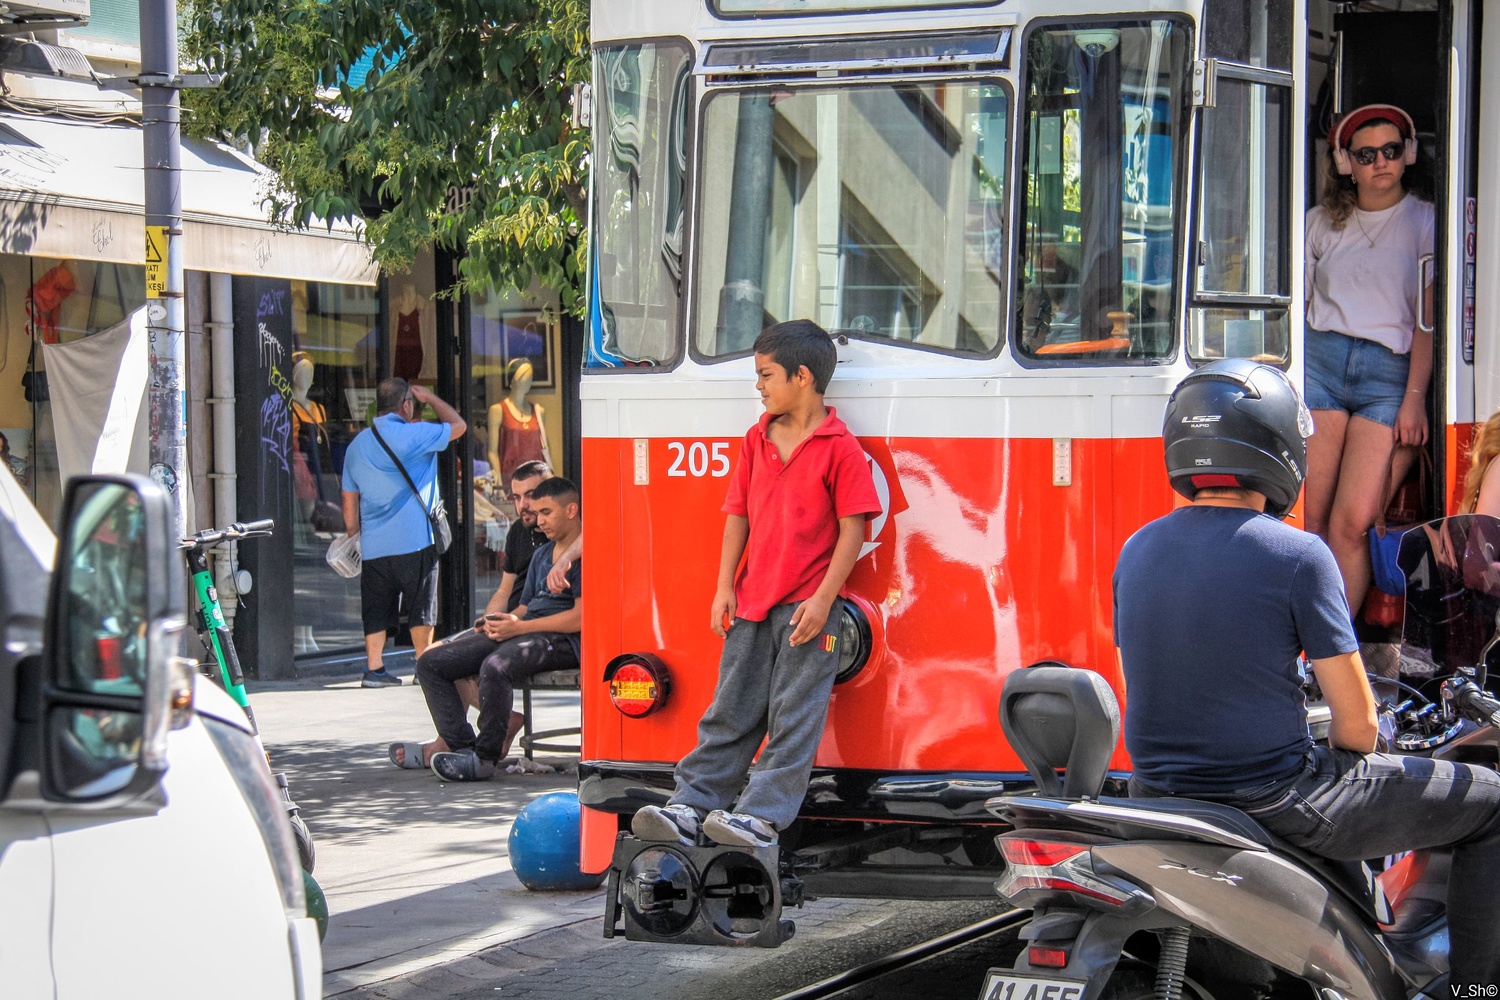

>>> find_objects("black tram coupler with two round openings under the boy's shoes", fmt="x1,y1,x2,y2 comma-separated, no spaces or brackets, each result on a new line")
605,834,803,948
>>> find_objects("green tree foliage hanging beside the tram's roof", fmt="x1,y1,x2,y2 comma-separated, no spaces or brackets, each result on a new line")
182,0,588,309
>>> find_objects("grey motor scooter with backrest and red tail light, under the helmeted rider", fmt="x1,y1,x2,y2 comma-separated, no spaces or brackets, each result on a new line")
981,514,1500,1000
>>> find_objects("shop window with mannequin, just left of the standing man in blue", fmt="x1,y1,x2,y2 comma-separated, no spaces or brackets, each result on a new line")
288,282,381,654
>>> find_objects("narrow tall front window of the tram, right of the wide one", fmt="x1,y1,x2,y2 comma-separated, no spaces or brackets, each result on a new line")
1016,19,1191,364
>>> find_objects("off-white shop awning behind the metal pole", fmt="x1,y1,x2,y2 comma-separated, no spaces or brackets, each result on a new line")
0,114,378,285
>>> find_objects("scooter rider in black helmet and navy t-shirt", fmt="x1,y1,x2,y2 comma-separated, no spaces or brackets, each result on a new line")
1115,360,1500,996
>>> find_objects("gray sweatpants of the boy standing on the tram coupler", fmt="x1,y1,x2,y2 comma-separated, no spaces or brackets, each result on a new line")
672,604,839,829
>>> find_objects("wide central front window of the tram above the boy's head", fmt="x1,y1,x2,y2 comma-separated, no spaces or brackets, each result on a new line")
695,82,1010,358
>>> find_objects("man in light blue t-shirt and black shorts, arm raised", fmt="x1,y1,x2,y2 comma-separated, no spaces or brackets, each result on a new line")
344,378,468,688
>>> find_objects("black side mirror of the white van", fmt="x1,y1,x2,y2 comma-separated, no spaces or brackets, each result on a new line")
41,475,191,810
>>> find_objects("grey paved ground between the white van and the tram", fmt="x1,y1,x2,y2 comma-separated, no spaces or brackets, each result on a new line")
251,676,1020,1000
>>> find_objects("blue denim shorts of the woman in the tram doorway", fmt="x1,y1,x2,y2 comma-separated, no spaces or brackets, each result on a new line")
1305,327,1412,427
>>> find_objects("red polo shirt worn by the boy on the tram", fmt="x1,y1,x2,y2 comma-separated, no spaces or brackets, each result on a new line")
725,406,881,622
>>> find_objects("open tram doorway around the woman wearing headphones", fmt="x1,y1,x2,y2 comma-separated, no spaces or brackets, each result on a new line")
1305,0,1484,517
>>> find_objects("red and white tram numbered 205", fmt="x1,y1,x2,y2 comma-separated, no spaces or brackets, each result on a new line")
579,0,1500,947
